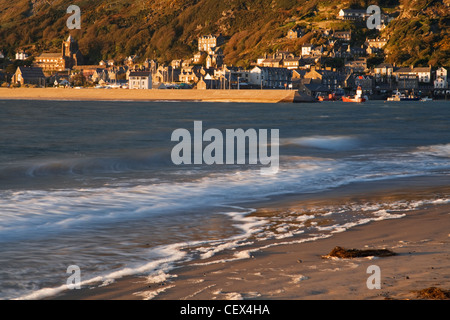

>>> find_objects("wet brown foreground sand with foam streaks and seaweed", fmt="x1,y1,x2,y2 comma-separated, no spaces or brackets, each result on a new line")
52,182,450,300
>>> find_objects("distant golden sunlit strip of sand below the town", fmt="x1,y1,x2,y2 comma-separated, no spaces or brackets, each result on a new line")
0,88,302,103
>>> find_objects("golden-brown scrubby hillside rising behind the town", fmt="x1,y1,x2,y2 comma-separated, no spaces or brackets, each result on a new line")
0,0,450,66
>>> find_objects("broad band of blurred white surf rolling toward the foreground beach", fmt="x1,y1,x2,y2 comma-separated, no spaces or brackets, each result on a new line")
0,148,448,242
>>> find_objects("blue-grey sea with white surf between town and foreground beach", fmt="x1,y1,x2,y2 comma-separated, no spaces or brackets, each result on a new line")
0,100,450,299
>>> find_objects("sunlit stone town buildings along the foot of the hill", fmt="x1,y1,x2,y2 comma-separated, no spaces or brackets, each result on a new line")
0,9,450,101
